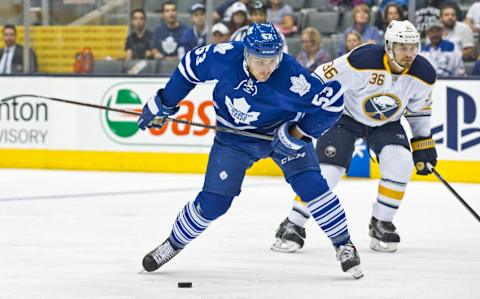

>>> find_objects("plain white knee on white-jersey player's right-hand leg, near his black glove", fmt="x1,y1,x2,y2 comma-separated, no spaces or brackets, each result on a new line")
379,145,414,183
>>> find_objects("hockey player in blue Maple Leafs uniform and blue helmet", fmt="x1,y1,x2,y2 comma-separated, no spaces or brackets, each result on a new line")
138,23,363,278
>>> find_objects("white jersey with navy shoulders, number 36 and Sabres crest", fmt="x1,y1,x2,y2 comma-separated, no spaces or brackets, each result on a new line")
314,44,436,137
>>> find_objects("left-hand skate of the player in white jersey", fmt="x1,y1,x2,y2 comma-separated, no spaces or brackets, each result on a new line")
270,217,306,252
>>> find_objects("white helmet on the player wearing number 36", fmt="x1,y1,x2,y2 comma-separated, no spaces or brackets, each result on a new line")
385,20,421,69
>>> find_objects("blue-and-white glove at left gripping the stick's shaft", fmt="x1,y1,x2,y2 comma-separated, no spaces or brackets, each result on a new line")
137,89,180,130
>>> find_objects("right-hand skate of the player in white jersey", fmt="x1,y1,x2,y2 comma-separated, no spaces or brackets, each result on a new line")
368,217,400,252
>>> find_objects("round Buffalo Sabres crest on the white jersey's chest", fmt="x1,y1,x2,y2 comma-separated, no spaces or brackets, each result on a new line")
363,94,402,121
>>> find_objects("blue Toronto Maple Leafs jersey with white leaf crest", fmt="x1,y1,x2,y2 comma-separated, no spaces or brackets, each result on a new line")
163,42,343,142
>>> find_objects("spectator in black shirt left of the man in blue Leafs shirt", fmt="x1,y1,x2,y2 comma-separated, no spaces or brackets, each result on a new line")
125,8,153,65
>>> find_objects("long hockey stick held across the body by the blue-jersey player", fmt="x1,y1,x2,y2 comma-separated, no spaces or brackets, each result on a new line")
1,94,273,141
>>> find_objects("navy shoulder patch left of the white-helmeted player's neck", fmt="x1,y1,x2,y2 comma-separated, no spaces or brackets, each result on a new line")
347,44,385,70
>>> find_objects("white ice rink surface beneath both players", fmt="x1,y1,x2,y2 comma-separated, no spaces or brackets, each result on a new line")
0,170,480,299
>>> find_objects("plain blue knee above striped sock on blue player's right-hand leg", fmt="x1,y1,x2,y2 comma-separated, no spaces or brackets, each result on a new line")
289,171,330,203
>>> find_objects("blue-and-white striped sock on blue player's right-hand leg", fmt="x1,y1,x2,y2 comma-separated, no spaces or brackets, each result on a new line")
308,191,350,247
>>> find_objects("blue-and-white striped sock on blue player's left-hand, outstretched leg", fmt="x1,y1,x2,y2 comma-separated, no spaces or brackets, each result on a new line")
169,201,211,249
